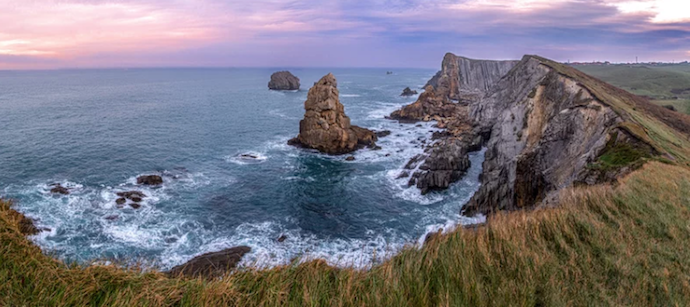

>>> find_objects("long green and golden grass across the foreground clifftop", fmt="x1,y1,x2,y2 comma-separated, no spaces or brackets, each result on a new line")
0,162,690,306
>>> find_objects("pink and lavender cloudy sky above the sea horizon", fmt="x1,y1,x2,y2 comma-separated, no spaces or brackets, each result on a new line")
0,0,690,69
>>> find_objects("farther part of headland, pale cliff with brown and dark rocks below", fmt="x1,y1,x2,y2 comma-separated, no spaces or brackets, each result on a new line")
389,53,516,194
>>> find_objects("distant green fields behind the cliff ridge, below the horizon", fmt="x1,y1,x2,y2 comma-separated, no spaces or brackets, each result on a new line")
576,65,690,114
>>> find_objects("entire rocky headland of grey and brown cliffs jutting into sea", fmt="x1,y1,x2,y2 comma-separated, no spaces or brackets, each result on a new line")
390,54,675,215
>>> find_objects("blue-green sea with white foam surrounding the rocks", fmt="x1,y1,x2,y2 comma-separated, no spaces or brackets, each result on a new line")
0,69,483,268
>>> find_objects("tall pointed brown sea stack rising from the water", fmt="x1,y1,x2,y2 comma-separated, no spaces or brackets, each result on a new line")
288,73,377,155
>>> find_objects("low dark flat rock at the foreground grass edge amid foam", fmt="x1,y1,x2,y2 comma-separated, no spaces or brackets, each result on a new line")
168,246,251,279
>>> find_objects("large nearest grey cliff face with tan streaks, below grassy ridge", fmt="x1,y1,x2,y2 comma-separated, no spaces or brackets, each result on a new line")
464,56,654,215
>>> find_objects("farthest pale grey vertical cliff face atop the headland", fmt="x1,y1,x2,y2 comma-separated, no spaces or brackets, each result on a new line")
427,53,518,103
